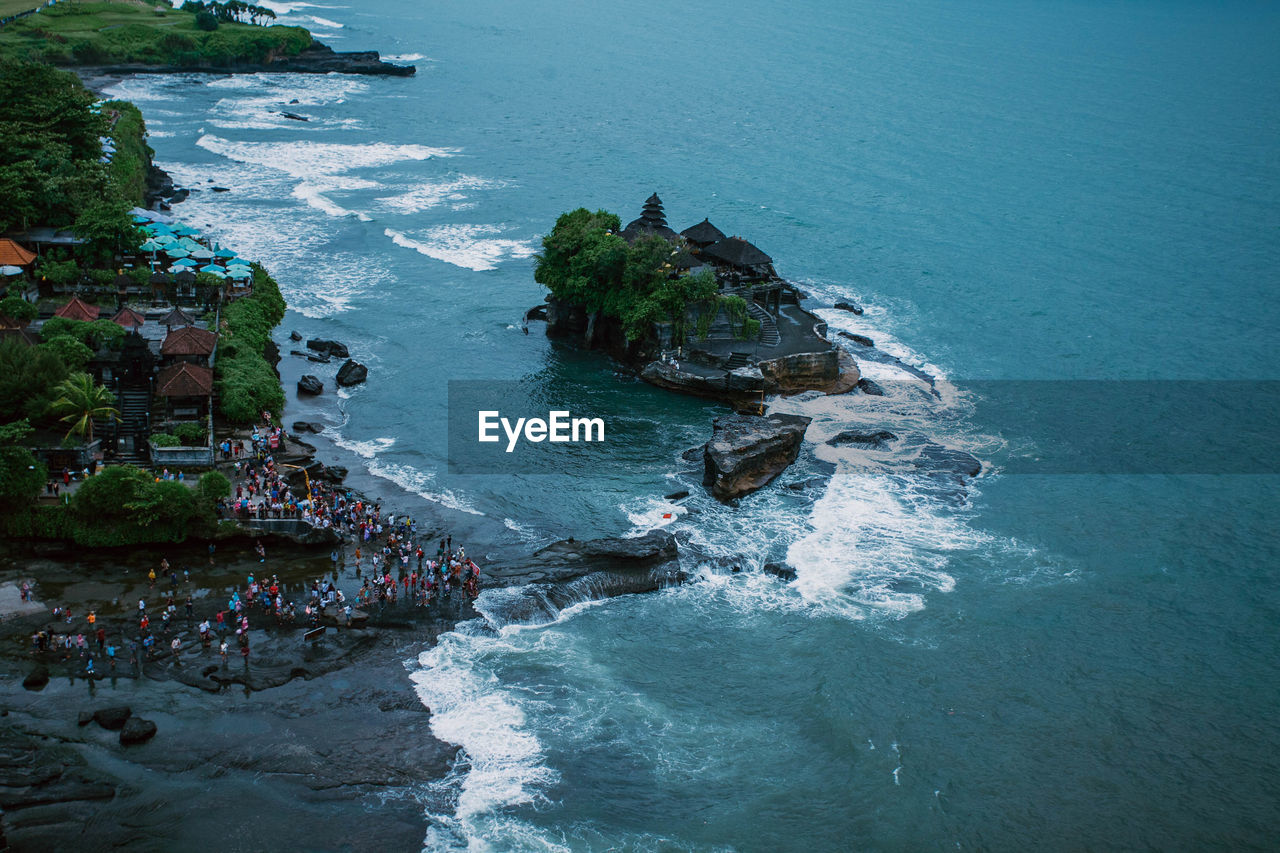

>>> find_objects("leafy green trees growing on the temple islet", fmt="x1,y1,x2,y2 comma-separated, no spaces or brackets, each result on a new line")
534,207,759,341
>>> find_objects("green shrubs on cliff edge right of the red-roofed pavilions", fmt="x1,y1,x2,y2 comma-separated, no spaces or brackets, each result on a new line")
215,264,284,424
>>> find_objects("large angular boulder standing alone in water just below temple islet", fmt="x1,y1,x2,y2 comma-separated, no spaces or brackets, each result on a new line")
703,415,812,502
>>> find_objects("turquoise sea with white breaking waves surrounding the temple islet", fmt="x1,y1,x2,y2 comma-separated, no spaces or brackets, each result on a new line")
113,0,1280,850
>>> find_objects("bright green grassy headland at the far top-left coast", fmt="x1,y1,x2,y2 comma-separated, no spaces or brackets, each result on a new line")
0,1,311,68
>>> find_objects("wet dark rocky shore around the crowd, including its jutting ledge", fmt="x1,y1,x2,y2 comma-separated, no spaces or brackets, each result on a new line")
0,356,682,850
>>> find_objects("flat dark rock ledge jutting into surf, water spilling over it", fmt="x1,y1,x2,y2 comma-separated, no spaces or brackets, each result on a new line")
486,530,684,624
